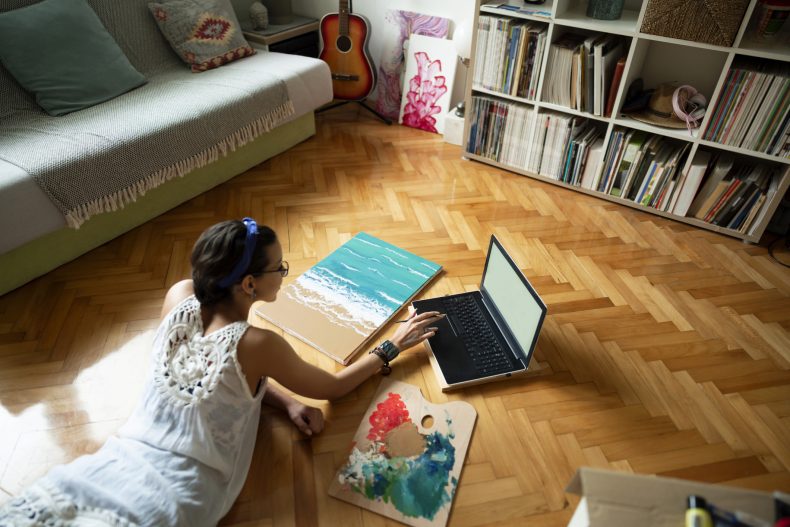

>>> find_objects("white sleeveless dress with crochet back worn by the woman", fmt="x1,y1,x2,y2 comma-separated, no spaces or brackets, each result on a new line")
0,296,266,527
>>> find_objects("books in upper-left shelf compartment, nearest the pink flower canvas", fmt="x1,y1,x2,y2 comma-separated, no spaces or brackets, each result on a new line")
472,15,546,99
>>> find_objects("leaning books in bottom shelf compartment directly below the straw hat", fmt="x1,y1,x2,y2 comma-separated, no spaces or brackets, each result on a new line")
592,129,690,211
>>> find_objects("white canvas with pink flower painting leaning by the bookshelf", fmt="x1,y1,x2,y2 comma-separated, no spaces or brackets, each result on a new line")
399,35,458,134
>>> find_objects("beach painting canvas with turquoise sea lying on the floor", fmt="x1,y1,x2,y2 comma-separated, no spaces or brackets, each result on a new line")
256,232,441,364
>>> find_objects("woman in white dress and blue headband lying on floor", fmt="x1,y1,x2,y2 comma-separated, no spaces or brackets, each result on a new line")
0,218,446,527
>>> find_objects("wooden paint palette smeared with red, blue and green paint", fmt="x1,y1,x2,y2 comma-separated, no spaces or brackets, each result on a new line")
329,379,477,526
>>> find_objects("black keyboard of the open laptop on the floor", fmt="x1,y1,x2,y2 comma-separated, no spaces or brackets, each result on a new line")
442,295,512,375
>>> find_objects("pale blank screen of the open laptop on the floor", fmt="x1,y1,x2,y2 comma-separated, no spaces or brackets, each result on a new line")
480,236,546,357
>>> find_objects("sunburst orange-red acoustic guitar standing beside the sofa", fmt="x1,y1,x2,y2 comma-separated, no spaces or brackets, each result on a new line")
319,0,376,101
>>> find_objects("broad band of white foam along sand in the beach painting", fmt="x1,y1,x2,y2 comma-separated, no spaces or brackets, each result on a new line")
285,270,392,337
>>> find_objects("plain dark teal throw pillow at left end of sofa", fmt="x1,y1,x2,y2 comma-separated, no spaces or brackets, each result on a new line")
0,0,146,115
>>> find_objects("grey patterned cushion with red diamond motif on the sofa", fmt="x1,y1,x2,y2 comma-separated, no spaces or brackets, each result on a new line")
148,0,255,72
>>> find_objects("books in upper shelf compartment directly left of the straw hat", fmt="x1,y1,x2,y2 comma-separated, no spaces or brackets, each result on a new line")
543,33,627,117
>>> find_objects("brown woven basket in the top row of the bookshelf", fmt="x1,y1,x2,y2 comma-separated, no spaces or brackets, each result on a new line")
642,0,749,46
